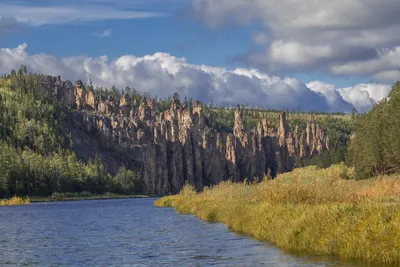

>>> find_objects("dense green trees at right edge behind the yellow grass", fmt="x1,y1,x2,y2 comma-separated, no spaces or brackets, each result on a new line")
349,82,400,178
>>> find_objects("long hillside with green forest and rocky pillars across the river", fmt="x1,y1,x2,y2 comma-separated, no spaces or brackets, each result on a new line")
0,67,354,197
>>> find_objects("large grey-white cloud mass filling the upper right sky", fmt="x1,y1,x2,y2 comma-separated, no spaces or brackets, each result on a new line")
190,0,400,82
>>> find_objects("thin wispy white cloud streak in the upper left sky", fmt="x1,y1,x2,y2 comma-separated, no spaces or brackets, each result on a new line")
0,3,167,26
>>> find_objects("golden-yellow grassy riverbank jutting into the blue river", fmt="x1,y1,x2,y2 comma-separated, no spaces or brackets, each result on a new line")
155,165,400,265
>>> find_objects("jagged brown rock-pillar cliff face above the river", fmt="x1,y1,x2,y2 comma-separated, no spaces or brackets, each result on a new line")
43,77,329,195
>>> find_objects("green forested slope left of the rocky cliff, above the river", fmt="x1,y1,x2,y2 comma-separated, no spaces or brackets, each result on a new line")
0,68,139,198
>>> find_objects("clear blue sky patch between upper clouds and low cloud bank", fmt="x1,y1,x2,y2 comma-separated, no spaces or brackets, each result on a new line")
0,0,251,67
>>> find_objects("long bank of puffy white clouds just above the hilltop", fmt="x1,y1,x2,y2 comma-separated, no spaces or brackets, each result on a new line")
0,44,390,112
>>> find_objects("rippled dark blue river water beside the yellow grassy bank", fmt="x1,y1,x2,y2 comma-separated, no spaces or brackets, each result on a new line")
0,199,394,267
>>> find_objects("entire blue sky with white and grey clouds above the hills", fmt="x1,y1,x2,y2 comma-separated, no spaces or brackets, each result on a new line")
0,0,400,112
